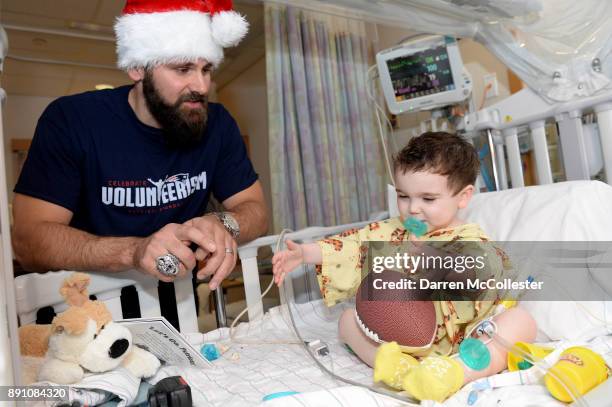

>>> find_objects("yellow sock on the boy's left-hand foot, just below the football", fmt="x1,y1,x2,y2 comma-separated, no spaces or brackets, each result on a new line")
374,342,419,390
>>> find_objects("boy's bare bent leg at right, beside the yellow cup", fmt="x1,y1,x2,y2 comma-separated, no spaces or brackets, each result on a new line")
457,307,537,383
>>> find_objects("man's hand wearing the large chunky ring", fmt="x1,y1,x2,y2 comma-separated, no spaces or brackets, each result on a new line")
133,223,216,282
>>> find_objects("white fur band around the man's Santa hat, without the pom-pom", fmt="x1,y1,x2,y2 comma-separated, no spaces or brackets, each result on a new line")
115,11,223,70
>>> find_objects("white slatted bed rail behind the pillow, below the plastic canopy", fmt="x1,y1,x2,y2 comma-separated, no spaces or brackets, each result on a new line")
463,88,612,190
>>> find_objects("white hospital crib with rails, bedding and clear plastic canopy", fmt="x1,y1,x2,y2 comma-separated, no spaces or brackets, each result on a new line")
0,0,612,406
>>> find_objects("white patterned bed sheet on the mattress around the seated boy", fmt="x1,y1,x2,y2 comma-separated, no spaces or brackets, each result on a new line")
152,301,612,407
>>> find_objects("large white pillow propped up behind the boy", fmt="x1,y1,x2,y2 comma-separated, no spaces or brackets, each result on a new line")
460,181,612,341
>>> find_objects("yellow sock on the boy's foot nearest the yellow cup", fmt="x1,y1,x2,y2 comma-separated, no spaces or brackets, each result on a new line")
402,356,463,402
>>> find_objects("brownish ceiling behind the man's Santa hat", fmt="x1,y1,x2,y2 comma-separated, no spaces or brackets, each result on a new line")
0,0,265,97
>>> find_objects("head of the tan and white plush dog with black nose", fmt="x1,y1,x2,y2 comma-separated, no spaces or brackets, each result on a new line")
19,273,160,384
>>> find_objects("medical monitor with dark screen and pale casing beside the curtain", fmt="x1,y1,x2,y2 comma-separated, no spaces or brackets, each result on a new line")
376,36,471,114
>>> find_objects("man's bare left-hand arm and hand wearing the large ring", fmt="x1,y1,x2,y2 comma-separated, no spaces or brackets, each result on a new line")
12,194,215,281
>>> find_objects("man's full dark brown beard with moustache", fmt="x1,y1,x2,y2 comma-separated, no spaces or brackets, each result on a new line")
142,70,208,149
